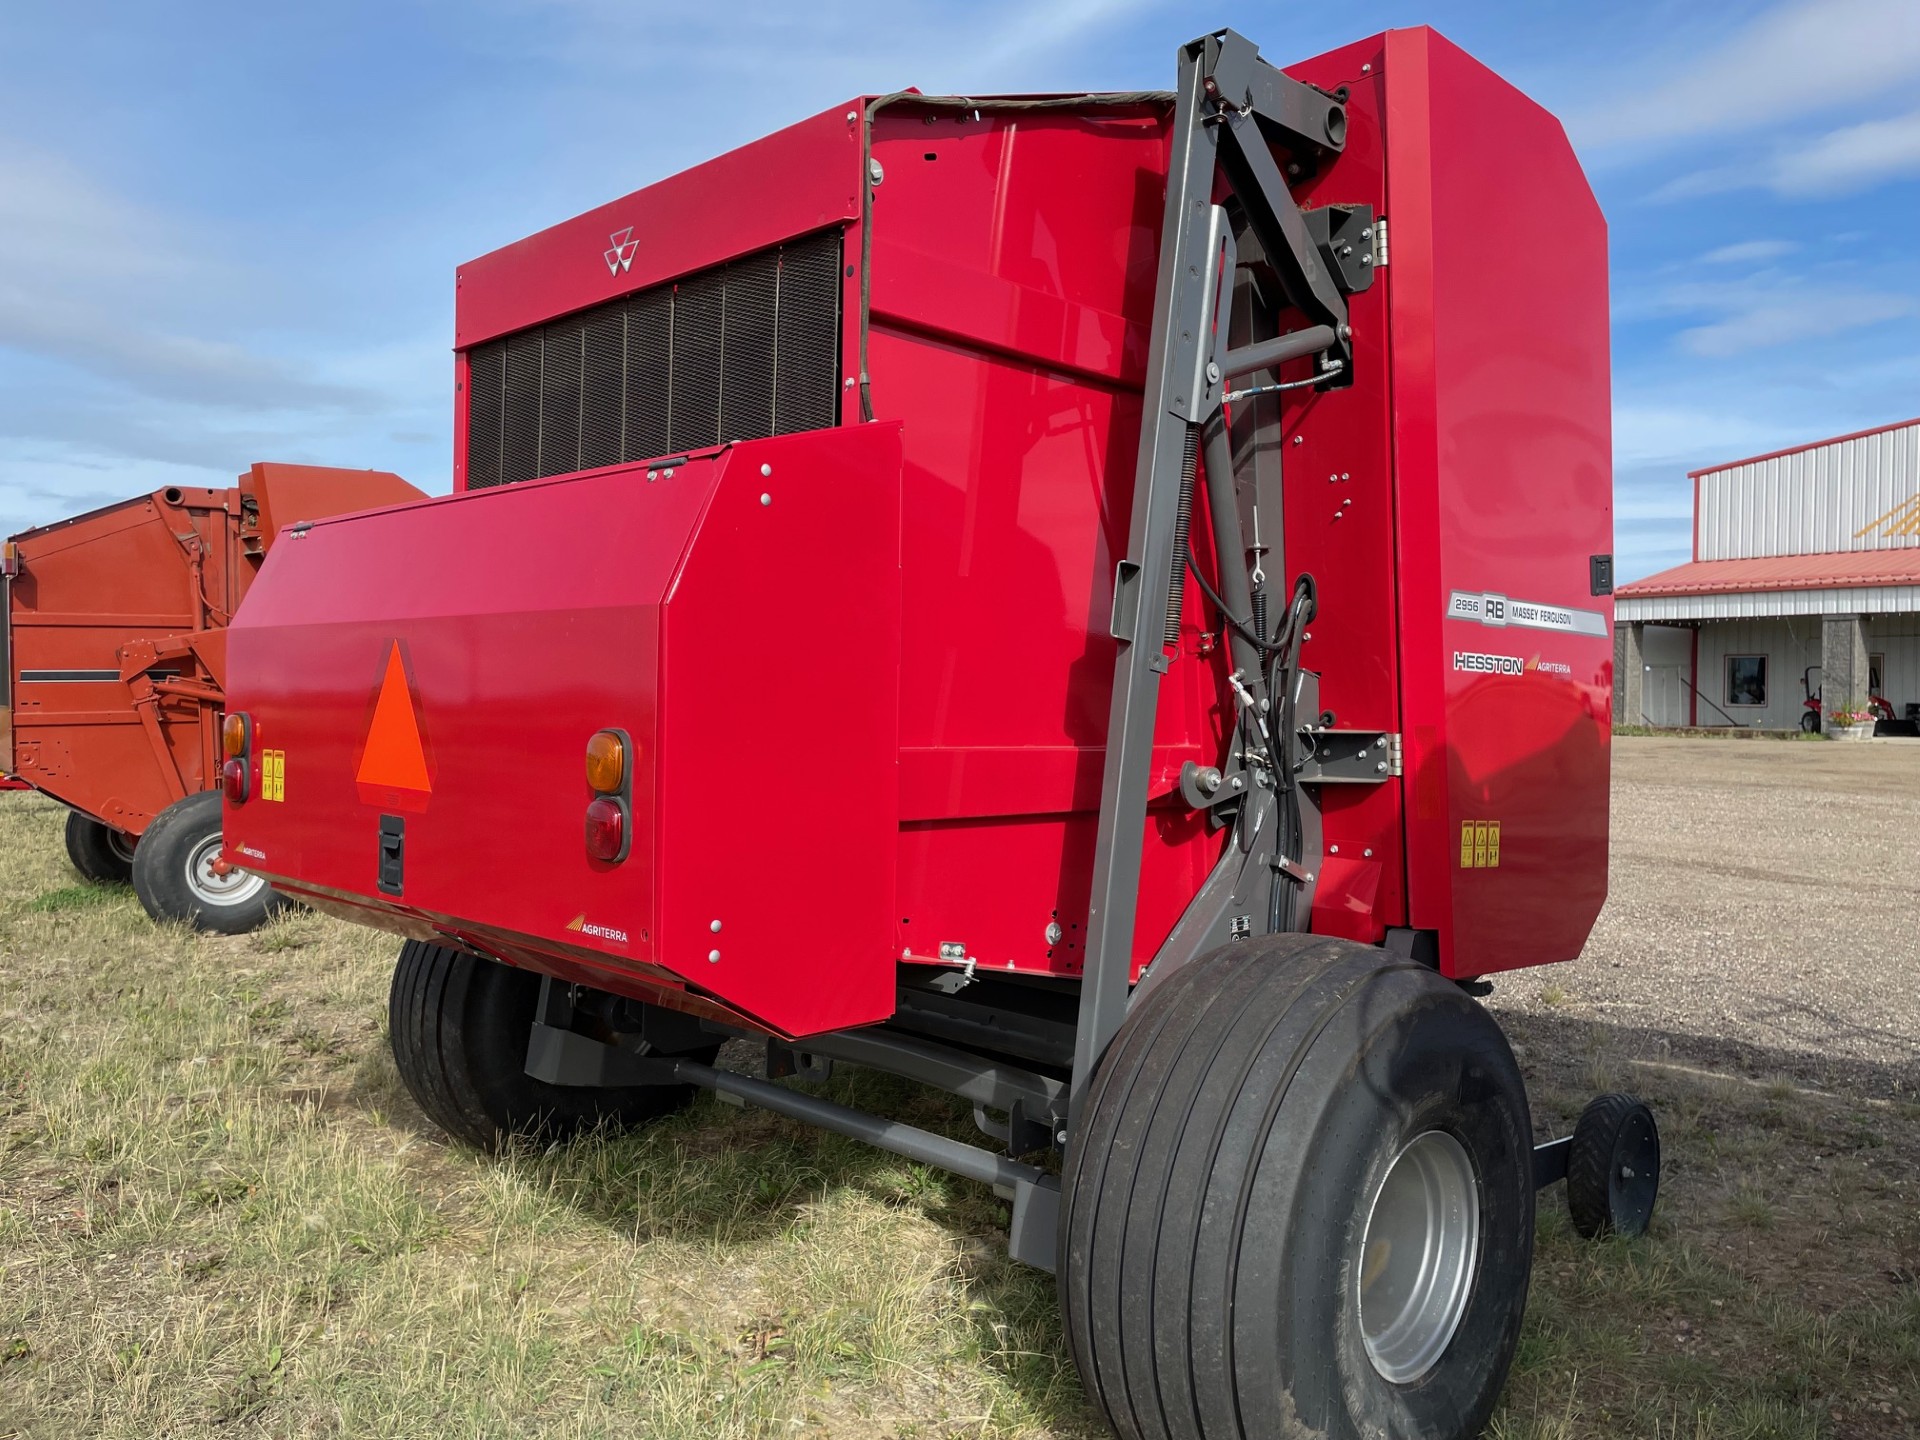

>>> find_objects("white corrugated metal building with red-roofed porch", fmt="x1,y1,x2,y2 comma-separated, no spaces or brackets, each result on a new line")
1613,419,1920,730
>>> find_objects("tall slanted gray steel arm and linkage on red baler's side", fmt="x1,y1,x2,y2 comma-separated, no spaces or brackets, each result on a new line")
1073,31,1352,1104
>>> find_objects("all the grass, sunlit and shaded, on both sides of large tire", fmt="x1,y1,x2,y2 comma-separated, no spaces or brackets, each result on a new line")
0,797,1920,1440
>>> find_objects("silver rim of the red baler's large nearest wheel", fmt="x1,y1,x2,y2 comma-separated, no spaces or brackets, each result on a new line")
1359,1131,1480,1384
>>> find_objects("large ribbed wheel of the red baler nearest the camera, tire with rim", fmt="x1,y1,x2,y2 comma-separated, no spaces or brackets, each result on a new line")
1058,935,1534,1440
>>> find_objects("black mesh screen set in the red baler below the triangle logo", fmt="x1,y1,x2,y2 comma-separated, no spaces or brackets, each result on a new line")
467,230,841,490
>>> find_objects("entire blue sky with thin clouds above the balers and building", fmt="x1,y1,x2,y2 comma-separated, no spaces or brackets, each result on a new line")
0,0,1920,578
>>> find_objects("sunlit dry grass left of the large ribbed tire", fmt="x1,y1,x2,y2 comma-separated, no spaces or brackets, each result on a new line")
0,797,1089,1440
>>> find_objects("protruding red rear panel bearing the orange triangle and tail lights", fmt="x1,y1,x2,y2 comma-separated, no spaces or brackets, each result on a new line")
225,426,900,1033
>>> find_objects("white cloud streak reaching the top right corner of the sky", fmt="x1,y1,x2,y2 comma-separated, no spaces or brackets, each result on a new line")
1567,0,1920,148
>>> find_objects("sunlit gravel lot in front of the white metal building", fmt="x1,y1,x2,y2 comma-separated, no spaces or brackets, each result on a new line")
1492,737,1920,1096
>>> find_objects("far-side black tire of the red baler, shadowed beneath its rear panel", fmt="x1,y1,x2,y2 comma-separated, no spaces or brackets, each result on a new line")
388,941,718,1152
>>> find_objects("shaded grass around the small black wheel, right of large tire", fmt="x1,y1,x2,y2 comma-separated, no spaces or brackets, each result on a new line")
1490,1014,1920,1440
